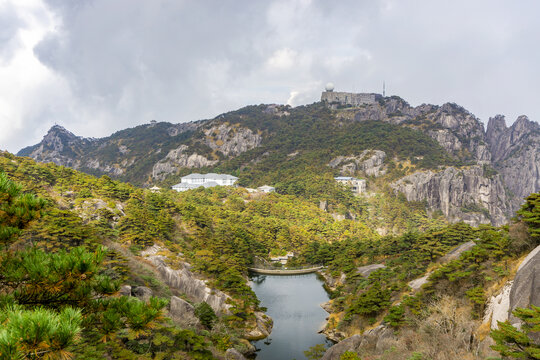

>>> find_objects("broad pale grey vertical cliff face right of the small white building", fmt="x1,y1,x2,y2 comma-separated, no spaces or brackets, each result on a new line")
391,165,512,226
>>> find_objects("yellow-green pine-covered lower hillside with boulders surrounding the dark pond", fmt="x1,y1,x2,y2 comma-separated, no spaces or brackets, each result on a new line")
0,153,540,359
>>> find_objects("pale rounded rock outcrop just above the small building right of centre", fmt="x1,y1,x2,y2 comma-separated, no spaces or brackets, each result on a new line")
328,150,386,177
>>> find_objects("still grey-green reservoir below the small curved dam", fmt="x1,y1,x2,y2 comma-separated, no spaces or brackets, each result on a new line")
251,273,330,360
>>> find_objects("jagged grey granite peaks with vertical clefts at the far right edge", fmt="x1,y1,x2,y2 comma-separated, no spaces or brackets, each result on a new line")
486,115,540,211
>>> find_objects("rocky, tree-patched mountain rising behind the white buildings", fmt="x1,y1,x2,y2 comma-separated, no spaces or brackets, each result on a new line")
19,96,540,225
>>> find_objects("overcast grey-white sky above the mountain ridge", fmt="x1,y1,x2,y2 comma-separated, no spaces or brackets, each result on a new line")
0,0,540,152
